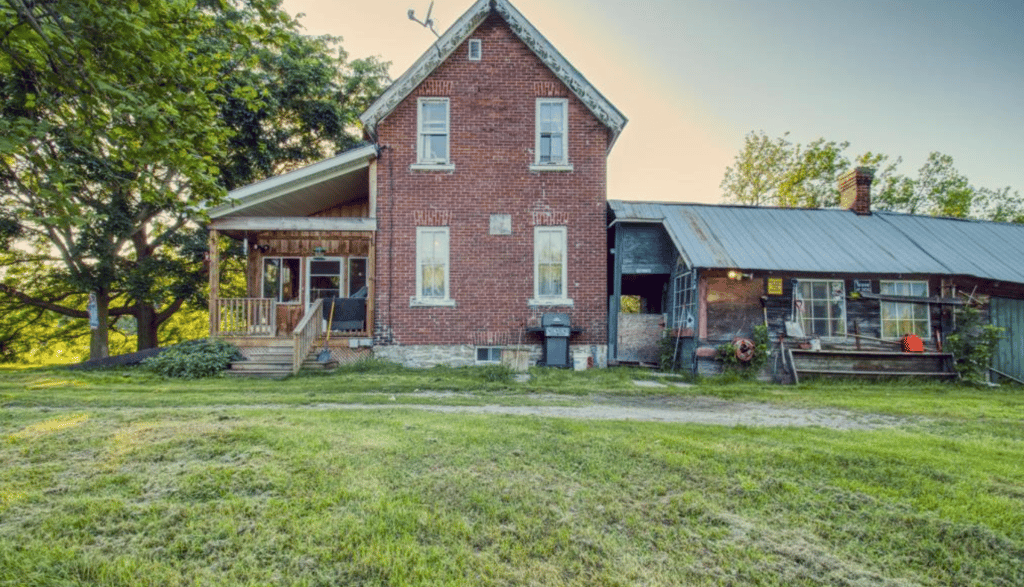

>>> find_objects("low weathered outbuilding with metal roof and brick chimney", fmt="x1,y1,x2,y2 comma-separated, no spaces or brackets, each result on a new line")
608,168,1024,380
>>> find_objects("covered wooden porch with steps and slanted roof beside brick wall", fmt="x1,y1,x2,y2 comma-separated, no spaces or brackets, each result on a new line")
209,145,377,373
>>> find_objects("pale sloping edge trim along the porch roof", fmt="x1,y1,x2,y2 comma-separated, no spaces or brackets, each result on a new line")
209,144,377,218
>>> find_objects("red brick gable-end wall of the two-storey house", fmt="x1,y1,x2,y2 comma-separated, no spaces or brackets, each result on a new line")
376,15,608,345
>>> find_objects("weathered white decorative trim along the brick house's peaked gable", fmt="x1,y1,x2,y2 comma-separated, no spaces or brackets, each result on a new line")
359,0,627,151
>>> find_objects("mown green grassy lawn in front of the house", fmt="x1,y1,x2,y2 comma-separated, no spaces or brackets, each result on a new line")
0,367,1024,586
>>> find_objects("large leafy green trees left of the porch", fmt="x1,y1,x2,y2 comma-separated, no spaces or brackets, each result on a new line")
0,0,386,358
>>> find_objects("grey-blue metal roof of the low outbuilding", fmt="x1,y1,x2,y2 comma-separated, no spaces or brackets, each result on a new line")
608,200,1024,283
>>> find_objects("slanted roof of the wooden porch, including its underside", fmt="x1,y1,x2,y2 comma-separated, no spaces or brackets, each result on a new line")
208,144,377,221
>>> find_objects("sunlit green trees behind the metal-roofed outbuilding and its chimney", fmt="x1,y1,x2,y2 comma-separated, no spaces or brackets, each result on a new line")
721,132,1024,222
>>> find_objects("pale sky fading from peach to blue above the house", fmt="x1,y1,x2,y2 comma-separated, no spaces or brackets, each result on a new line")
284,0,1024,203
